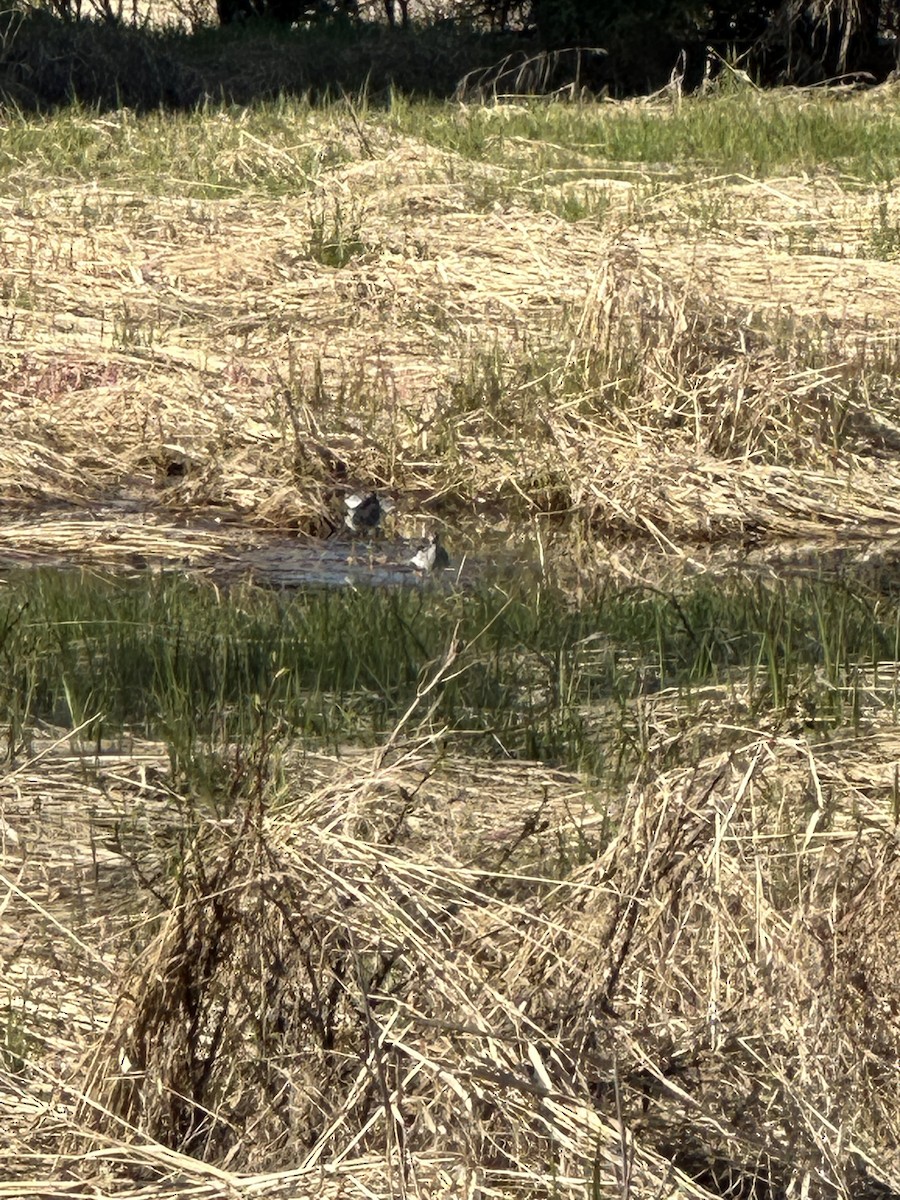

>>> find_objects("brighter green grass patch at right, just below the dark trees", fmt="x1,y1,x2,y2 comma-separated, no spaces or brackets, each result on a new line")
391,88,900,184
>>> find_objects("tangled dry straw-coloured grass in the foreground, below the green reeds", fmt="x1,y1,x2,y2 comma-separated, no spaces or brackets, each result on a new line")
0,698,900,1198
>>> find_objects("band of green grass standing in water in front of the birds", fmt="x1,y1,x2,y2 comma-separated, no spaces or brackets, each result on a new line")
0,571,900,776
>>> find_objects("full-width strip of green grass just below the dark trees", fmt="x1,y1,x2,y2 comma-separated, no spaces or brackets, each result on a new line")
0,90,900,200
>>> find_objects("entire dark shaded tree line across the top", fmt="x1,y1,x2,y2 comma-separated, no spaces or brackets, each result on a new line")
0,0,900,110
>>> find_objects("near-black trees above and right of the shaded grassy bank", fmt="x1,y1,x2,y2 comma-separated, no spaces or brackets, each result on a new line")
217,0,900,90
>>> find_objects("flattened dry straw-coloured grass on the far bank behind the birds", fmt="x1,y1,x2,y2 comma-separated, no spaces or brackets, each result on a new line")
0,103,900,561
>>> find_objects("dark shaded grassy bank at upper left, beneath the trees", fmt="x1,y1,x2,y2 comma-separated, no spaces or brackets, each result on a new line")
0,12,549,112
